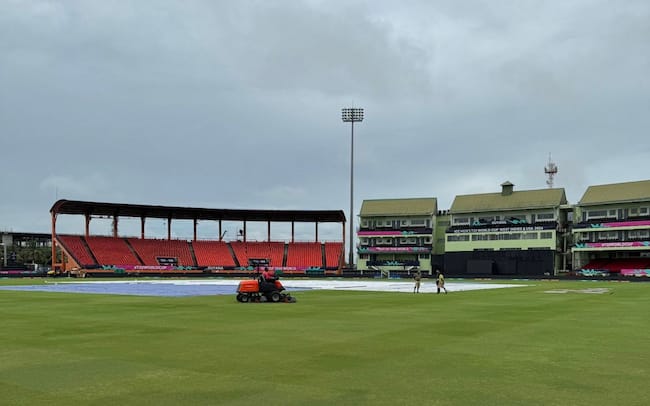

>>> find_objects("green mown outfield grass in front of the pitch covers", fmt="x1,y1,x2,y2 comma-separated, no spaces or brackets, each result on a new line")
0,279,650,405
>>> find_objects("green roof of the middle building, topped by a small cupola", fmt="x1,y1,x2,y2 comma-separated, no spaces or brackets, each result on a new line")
450,183,567,214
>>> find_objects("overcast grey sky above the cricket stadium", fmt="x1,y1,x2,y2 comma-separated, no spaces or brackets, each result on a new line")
0,0,650,239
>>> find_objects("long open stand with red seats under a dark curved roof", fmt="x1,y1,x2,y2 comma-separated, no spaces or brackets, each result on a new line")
50,199,346,276
